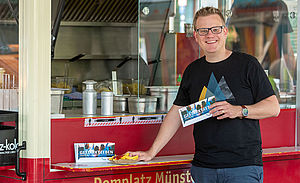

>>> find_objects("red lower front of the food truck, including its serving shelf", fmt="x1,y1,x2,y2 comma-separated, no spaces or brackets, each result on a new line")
0,109,300,183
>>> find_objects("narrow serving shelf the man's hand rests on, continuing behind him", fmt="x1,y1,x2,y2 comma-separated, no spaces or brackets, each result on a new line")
52,147,300,172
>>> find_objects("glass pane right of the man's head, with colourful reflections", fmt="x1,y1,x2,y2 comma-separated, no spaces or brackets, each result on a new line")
224,0,297,108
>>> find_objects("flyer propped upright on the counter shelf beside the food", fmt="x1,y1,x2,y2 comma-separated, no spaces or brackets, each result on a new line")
74,142,115,162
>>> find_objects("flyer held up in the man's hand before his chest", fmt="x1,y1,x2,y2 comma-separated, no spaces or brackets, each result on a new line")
178,96,216,127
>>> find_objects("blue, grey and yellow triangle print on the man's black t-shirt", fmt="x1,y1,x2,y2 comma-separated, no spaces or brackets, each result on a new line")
199,72,234,101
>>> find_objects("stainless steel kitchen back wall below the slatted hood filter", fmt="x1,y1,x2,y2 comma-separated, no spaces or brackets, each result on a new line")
52,23,137,85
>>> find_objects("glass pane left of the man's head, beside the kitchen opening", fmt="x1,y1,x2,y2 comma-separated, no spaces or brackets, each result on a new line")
139,0,199,86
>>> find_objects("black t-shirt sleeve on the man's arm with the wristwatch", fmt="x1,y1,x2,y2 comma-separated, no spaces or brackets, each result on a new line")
247,57,275,103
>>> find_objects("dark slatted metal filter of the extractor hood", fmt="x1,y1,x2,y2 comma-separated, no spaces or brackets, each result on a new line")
54,0,138,23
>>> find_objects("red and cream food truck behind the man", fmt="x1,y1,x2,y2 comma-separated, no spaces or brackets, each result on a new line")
0,0,300,183
